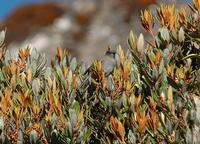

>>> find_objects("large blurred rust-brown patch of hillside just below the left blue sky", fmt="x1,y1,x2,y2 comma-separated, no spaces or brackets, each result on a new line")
3,3,64,44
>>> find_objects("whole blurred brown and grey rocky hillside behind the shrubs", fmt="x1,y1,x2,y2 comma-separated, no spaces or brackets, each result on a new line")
1,0,188,63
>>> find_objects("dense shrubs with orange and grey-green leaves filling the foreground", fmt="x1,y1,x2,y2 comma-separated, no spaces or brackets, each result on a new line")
0,0,200,144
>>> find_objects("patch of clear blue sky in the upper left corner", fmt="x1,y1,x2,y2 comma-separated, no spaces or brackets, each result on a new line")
0,0,45,19
